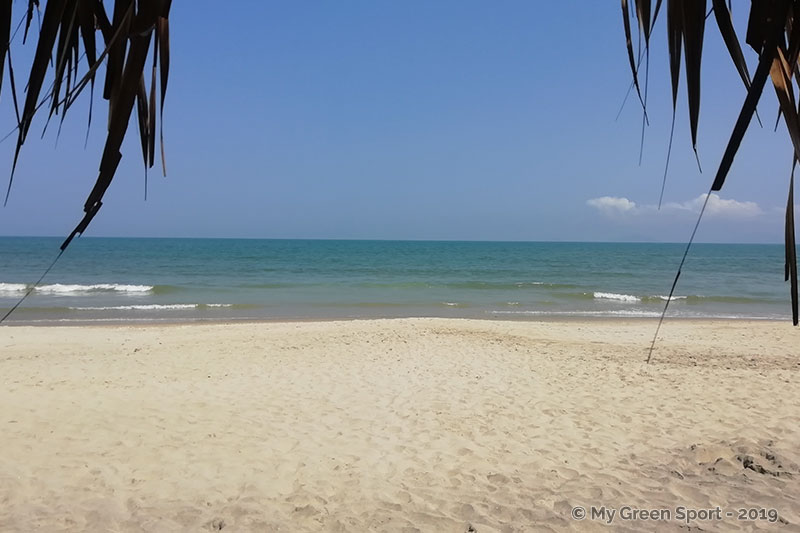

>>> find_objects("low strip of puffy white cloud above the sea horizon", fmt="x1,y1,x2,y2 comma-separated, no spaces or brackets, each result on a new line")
586,193,763,218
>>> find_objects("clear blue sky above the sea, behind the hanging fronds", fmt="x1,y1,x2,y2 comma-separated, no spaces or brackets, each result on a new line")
0,0,792,242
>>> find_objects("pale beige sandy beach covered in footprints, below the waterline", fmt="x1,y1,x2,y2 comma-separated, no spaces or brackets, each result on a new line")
0,319,800,533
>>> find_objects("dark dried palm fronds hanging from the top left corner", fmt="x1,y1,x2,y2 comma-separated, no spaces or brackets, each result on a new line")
0,0,171,251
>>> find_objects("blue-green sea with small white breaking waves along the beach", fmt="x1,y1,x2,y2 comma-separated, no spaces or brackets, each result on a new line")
0,237,791,325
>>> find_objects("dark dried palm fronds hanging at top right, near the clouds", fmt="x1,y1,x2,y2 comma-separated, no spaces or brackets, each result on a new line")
622,0,800,325
